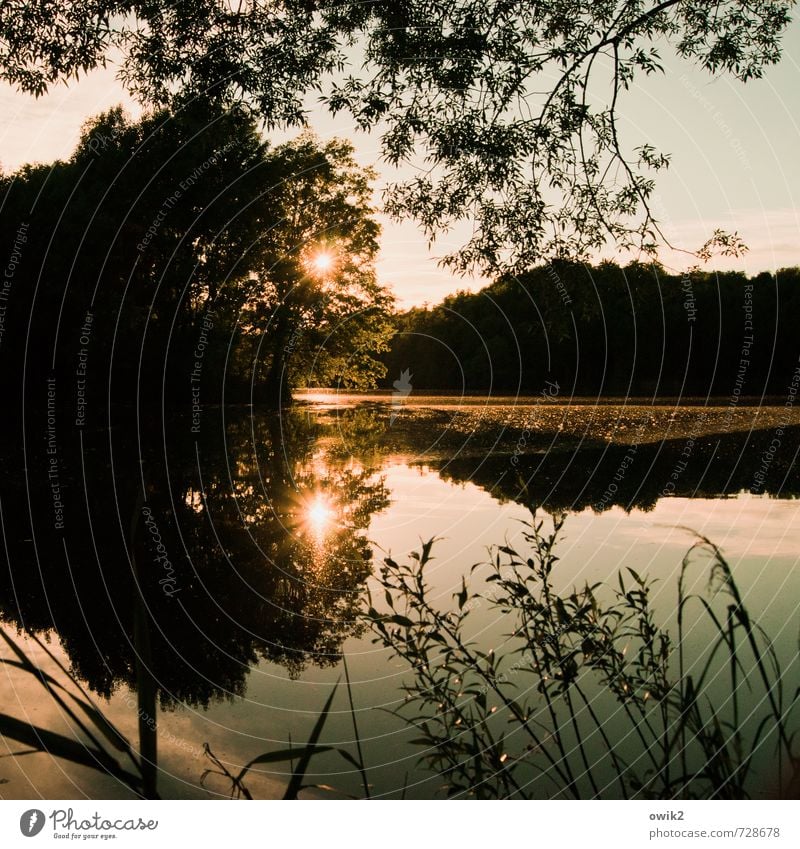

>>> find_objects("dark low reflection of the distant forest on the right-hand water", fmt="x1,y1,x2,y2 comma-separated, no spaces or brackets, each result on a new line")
387,408,800,513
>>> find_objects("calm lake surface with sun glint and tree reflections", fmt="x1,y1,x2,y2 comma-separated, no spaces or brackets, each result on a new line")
0,390,800,799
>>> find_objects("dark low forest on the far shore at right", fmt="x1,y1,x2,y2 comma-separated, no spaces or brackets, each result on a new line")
383,262,800,399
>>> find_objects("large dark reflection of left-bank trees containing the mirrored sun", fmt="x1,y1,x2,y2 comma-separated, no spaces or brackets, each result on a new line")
0,411,388,704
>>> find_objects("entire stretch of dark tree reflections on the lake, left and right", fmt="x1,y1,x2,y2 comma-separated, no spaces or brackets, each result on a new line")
0,406,800,704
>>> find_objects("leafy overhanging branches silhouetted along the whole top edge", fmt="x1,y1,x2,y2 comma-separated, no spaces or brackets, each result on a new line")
0,0,794,271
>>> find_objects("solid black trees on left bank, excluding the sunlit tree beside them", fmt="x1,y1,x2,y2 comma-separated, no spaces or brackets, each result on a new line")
0,101,272,404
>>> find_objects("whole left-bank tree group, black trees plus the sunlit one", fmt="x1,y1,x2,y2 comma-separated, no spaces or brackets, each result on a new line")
0,104,391,410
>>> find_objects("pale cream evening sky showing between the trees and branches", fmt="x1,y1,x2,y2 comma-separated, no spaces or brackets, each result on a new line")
0,20,800,307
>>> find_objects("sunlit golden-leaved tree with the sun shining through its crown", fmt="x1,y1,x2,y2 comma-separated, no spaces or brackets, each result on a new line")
236,133,394,404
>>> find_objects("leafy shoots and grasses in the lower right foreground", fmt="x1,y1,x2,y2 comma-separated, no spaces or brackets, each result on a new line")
368,516,800,799
